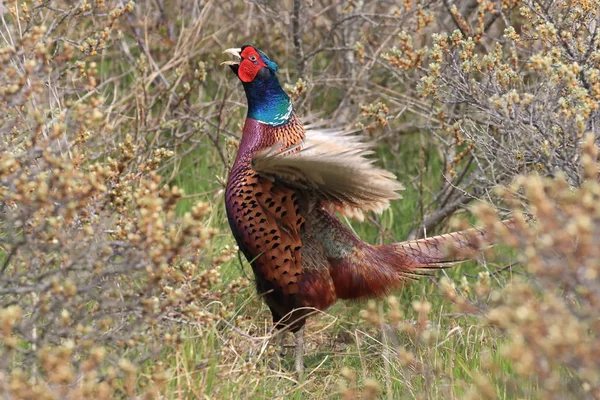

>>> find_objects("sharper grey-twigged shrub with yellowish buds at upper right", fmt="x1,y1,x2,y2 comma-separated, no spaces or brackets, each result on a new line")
383,0,600,236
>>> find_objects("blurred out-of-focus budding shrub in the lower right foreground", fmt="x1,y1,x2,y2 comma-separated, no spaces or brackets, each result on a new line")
362,136,600,399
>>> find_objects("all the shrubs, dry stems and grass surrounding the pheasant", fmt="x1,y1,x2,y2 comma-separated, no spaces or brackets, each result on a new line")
0,0,600,399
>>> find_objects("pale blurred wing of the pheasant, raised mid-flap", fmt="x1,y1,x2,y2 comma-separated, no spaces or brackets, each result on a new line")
252,129,404,219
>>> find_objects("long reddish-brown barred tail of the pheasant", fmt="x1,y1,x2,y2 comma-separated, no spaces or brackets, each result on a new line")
331,221,512,299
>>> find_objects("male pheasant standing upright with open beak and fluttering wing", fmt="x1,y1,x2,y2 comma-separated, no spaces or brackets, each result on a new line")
223,45,494,373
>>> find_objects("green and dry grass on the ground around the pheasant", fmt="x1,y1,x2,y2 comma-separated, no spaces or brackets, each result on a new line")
159,127,510,399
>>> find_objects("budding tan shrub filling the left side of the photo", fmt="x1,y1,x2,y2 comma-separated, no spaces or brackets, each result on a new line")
0,1,218,398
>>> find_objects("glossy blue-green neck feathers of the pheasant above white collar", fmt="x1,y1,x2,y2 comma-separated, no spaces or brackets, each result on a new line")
244,72,293,125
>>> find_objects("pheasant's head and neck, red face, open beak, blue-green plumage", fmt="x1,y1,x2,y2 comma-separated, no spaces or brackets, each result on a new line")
223,45,293,125
